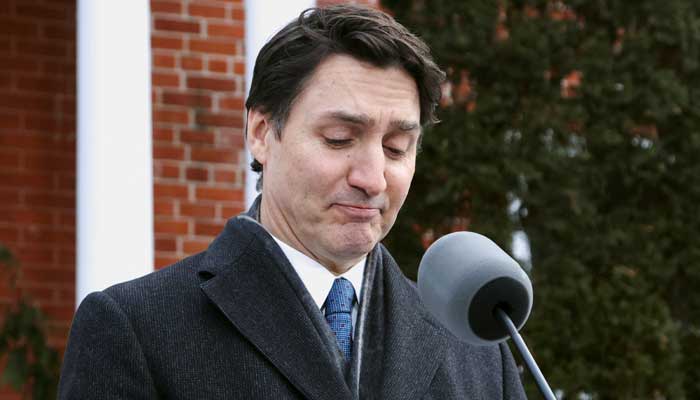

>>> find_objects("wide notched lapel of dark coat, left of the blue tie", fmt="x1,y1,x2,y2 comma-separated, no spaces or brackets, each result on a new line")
200,216,351,400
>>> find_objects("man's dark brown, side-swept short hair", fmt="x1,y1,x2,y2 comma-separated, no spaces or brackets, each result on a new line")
246,5,445,190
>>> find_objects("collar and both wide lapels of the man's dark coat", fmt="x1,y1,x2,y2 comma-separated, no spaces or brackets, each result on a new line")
199,198,447,400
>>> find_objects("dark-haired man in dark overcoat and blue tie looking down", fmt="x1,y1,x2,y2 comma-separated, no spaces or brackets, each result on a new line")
59,6,524,400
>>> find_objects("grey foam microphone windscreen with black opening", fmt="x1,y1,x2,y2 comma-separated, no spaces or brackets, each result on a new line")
418,232,532,345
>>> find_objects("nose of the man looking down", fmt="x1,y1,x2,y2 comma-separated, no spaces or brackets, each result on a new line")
348,145,386,197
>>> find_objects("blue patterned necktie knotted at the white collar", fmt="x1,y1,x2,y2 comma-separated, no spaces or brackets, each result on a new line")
325,278,355,360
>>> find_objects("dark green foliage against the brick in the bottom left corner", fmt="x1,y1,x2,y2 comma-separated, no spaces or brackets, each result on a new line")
0,244,60,400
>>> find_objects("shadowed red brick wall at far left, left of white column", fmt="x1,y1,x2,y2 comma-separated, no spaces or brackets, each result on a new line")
0,0,76,399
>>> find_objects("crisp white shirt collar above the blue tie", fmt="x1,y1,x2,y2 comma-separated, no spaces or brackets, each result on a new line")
270,234,367,309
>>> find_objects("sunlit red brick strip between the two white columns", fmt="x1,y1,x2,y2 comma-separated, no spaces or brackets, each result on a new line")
151,0,245,268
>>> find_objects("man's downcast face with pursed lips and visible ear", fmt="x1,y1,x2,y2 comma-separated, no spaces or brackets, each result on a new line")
248,55,420,273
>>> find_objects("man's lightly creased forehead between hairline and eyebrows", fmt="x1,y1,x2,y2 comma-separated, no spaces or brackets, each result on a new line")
290,55,420,123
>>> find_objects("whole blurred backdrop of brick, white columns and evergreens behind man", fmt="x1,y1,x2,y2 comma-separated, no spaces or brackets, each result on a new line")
0,0,700,399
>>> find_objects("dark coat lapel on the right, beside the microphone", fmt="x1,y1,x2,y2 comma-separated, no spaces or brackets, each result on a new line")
359,245,447,400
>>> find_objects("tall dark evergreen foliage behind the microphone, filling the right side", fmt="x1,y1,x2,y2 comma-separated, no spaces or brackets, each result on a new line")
383,0,700,399
